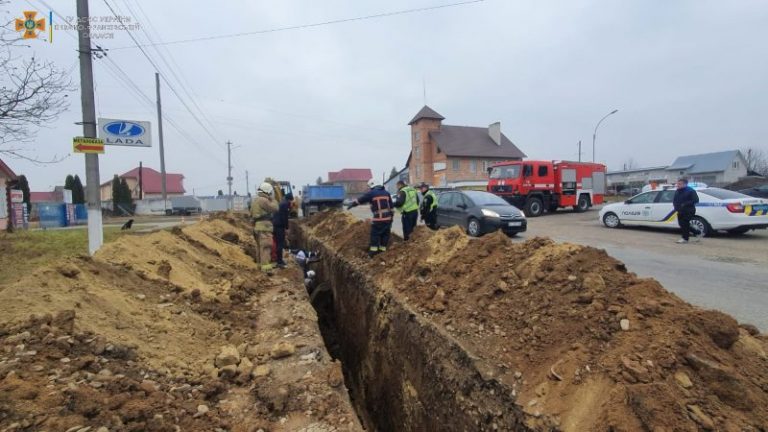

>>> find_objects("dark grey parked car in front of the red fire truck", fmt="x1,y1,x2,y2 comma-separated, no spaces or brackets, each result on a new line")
437,191,528,237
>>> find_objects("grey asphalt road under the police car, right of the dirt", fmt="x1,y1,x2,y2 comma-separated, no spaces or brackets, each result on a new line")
352,208,768,332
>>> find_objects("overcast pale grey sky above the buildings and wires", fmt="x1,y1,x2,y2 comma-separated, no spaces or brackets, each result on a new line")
5,0,768,194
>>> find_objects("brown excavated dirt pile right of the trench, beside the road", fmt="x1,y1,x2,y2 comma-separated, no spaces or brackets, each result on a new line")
311,214,768,432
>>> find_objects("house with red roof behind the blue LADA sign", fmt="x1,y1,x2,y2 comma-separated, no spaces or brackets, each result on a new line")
101,167,186,201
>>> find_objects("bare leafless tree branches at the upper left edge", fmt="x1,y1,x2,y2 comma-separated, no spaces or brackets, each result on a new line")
0,0,74,163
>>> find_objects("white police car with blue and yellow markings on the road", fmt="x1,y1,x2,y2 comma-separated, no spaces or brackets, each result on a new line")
599,187,768,235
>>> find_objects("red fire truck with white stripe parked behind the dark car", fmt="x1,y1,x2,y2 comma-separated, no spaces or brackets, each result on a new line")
488,160,606,217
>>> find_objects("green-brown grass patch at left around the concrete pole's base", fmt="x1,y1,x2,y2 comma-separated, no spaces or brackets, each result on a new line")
0,227,125,285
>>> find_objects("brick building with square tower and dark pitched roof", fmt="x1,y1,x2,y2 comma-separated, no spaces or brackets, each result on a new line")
407,105,525,187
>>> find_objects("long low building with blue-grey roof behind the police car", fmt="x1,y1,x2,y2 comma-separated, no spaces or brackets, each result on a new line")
607,150,747,190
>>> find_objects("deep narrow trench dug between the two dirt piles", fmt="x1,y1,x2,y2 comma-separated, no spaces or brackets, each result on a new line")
292,226,530,431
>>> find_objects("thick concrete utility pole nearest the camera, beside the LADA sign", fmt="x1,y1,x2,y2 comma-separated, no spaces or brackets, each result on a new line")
77,0,104,255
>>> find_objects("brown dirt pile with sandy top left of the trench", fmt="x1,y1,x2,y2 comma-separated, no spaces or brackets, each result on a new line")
0,216,360,432
